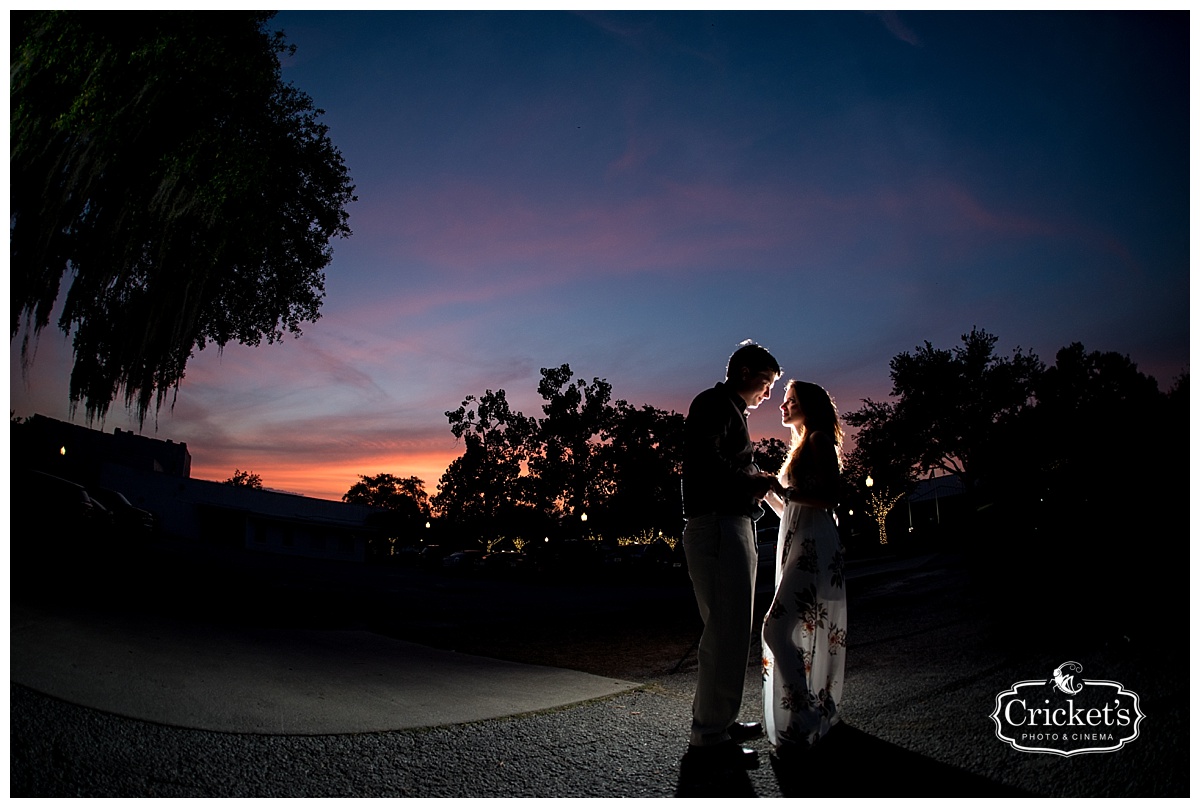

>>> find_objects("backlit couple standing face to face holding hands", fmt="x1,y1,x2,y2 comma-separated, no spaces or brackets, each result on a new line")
683,341,846,767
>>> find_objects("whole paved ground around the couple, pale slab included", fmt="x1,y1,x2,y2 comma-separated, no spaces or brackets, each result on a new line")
10,559,1189,800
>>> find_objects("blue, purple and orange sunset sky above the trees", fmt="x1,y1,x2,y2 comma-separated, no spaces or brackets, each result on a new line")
10,11,1189,499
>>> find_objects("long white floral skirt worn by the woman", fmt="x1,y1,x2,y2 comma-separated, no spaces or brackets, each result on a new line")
762,465,846,748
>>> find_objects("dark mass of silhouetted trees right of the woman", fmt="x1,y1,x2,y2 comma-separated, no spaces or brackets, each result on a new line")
846,329,1189,639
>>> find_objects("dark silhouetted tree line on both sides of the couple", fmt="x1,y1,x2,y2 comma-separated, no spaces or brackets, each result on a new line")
346,328,1189,633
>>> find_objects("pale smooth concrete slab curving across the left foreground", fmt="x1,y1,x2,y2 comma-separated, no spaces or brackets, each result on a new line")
10,558,923,735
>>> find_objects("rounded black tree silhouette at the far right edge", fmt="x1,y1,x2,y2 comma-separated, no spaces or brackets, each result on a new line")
978,342,1193,647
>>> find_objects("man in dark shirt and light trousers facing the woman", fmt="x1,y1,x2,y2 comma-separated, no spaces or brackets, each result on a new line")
683,341,780,766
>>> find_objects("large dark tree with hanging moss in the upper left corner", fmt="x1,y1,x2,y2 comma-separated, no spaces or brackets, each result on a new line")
10,11,355,421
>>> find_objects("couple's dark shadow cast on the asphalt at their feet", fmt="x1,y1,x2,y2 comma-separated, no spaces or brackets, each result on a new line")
676,723,1032,797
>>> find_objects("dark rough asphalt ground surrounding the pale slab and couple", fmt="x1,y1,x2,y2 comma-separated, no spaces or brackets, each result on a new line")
10,545,1190,797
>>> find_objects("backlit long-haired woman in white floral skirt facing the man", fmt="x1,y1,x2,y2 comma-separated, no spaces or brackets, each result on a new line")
762,381,846,759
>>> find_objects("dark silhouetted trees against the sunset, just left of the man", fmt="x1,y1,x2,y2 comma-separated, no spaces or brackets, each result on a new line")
431,364,683,538
